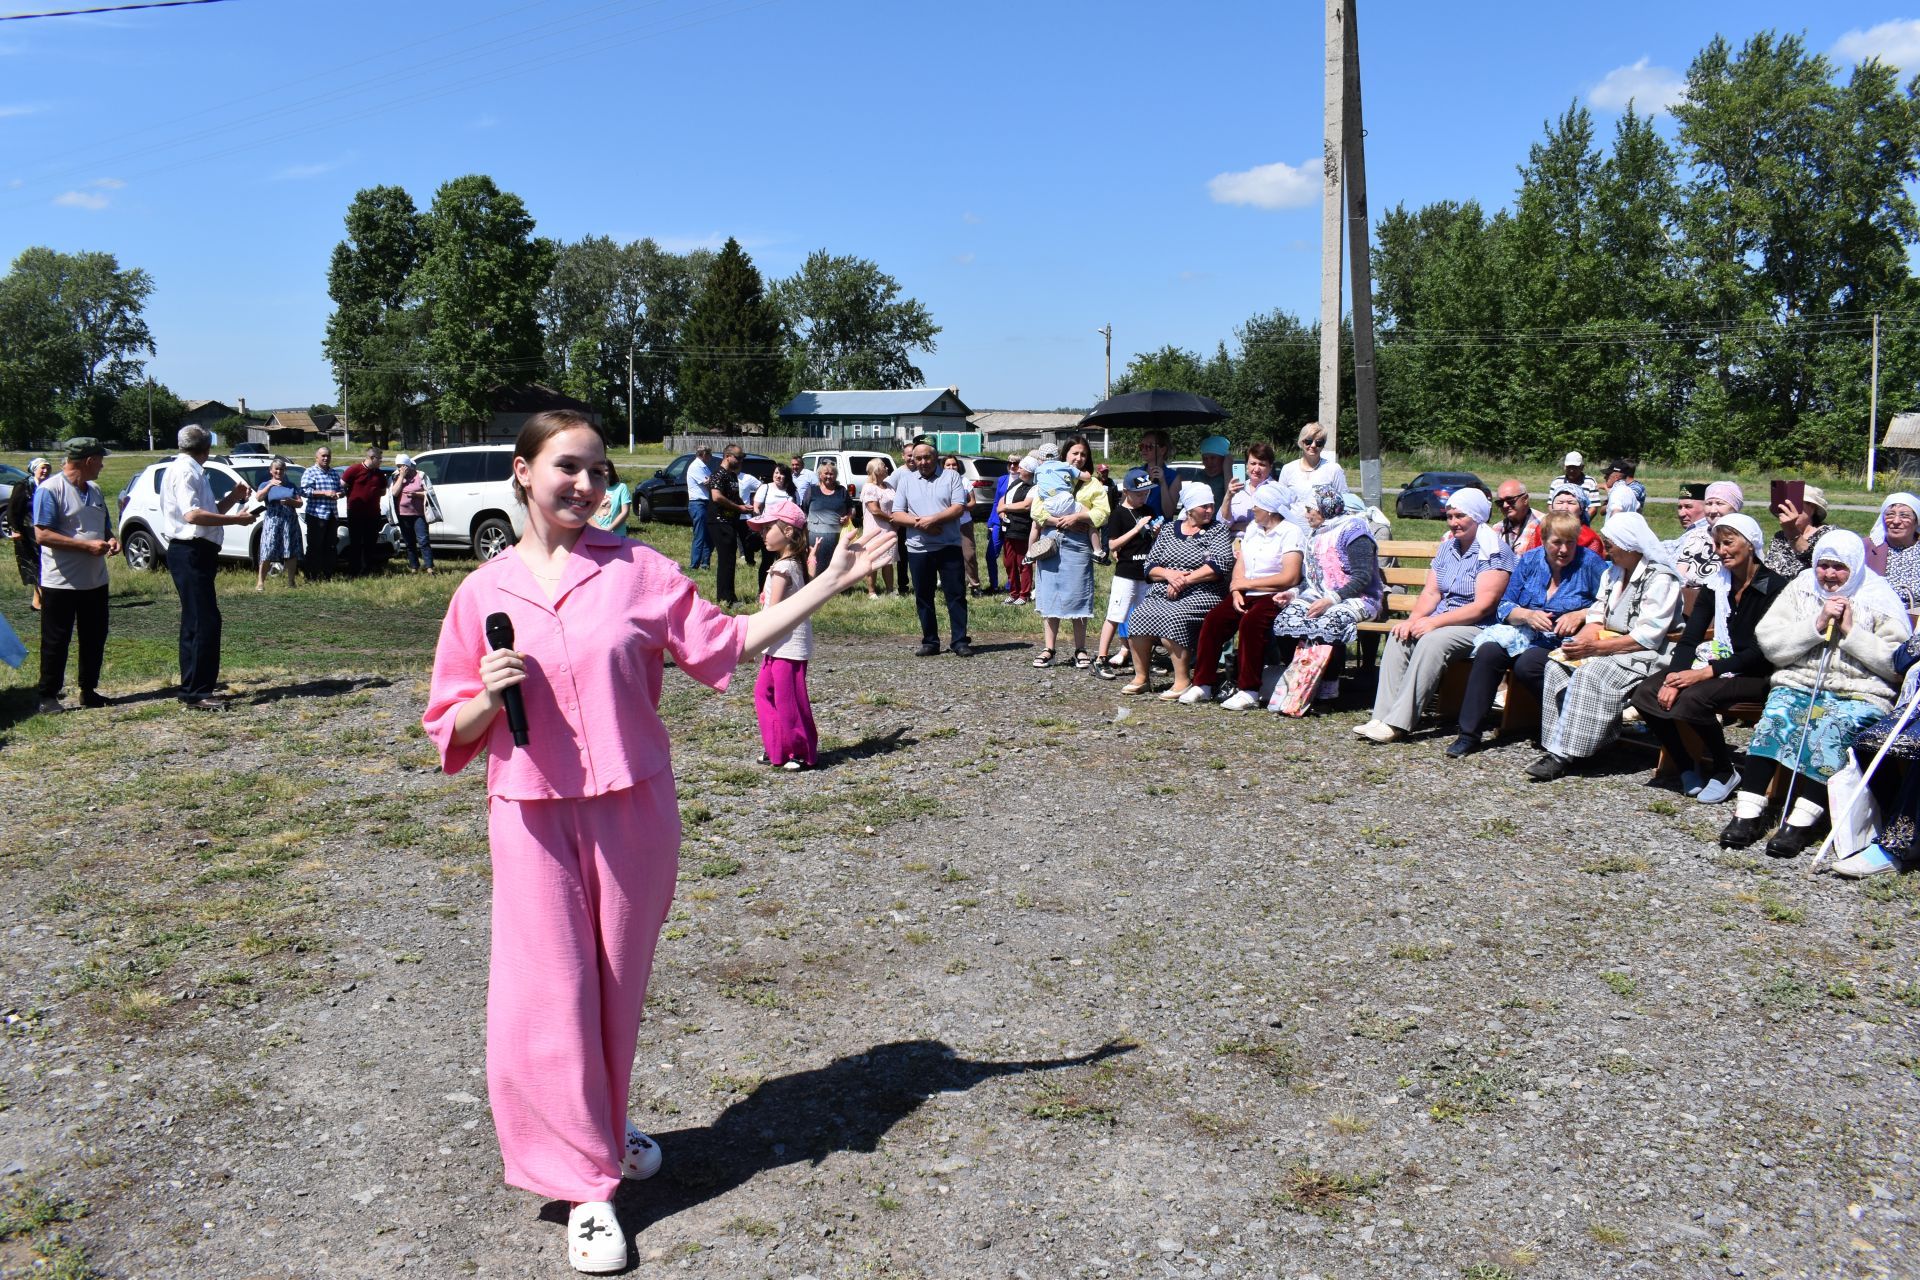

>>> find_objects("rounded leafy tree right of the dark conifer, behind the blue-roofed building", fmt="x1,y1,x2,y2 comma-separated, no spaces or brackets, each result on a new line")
772,249,941,393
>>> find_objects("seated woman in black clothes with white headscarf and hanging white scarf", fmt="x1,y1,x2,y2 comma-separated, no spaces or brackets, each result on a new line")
1634,510,1789,804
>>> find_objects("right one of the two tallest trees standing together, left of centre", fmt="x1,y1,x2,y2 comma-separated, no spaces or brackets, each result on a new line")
407,175,553,439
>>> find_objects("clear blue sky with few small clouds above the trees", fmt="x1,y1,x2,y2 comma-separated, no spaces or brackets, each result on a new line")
0,0,1920,409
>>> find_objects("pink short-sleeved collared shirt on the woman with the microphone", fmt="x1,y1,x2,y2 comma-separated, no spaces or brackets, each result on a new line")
420,526,747,800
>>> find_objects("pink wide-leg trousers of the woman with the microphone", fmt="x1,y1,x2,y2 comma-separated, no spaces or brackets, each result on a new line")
486,770,680,1203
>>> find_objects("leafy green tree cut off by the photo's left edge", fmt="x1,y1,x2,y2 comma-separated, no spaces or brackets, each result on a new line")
0,248,154,447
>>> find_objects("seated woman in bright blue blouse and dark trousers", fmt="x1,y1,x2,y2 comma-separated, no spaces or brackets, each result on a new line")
1446,510,1607,760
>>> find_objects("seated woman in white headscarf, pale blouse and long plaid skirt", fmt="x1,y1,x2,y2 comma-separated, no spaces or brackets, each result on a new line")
1526,510,1680,783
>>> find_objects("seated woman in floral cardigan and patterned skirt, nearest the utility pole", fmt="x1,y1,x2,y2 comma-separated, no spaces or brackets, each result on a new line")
1267,487,1386,716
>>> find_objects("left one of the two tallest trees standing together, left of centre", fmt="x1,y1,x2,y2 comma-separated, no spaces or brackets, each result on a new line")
321,186,426,445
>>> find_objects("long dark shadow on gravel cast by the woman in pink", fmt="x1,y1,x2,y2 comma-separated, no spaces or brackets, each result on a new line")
541,1040,1133,1234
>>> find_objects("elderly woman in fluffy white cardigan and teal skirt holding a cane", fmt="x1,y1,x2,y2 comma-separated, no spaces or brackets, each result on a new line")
1720,530,1912,858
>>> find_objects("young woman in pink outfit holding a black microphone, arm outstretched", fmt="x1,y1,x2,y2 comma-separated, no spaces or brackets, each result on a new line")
424,411,891,1272
